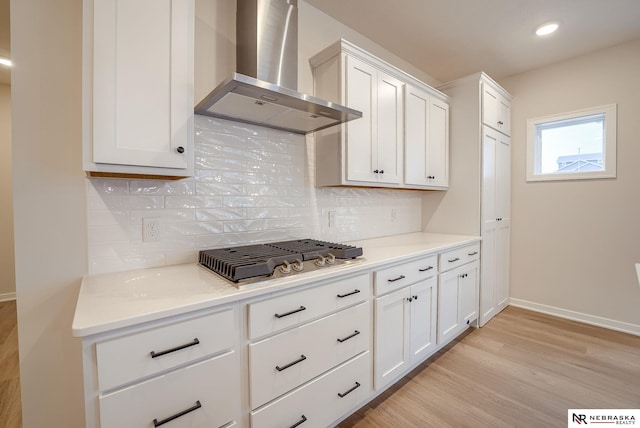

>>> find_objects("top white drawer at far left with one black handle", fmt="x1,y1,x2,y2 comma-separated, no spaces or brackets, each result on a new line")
96,309,238,391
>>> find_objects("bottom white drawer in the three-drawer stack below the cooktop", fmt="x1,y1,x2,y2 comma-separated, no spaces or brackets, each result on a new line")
251,352,371,428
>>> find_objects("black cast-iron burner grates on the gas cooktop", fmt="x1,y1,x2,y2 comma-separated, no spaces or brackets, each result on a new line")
198,239,362,282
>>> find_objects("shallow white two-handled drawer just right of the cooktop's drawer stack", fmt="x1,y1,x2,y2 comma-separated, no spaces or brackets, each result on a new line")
374,255,438,296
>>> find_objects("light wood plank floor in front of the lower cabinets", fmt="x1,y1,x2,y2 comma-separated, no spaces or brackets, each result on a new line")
339,307,640,428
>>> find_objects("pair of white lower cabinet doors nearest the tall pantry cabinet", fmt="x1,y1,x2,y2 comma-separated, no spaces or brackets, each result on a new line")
438,256,479,344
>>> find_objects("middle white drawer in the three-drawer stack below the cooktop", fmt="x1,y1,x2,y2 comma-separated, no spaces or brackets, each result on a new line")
249,302,371,409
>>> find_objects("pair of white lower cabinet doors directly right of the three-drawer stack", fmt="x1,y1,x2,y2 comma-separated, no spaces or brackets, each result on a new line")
374,263,438,389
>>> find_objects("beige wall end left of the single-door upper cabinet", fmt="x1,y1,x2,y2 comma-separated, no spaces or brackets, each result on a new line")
11,0,87,428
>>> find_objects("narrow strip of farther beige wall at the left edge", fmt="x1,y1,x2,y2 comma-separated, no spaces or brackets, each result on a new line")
0,84,16,301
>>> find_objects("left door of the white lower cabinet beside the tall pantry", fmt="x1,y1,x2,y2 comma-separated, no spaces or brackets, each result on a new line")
438,269,460,345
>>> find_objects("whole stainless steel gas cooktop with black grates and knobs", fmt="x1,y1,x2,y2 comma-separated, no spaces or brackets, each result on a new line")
199,239,364,284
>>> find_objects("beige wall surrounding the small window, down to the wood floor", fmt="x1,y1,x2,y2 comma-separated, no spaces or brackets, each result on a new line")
499,40,640,334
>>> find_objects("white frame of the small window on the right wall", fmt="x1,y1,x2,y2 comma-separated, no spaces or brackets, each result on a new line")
527,104,618,181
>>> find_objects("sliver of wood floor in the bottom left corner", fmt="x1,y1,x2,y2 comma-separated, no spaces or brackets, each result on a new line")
0,300,22,428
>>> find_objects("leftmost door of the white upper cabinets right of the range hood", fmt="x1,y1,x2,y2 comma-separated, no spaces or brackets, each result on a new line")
345,56,378,182
